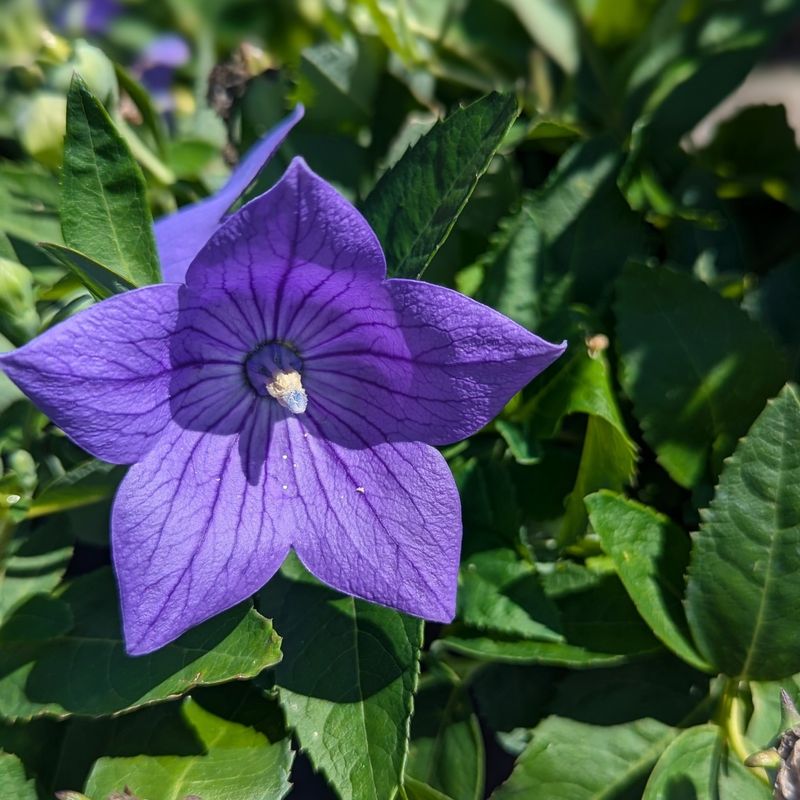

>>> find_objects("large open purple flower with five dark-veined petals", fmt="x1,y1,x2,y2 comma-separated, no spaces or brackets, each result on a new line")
0,108,564,654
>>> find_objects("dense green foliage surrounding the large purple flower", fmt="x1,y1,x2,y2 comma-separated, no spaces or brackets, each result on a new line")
0,0,800,800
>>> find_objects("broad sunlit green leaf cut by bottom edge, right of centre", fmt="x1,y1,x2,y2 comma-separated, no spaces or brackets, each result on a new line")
492,717,676,800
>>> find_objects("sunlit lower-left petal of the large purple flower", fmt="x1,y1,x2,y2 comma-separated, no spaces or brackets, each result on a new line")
111,416,289,655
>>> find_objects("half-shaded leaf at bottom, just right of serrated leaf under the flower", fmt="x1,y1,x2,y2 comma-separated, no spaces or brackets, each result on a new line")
405,665,484,800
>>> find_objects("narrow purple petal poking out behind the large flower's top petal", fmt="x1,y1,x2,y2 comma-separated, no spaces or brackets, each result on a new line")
154,105,304,283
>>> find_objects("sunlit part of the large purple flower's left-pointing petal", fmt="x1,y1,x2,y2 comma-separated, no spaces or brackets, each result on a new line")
0,284,178,464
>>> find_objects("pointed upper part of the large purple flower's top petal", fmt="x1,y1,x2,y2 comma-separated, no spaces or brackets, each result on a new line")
186,158,386,289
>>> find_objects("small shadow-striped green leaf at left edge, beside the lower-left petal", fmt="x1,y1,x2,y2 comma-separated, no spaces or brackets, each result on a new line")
0,522,72,630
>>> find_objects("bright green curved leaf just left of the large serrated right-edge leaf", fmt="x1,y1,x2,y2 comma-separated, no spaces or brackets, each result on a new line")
586,492,708,670
